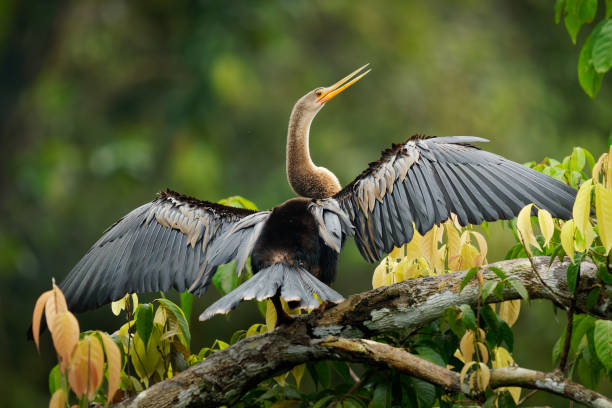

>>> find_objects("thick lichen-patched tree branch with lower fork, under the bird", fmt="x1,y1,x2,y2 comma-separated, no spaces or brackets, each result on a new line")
111,257,612,408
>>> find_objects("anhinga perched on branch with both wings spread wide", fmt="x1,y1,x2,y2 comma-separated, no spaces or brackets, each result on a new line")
60,67,576,320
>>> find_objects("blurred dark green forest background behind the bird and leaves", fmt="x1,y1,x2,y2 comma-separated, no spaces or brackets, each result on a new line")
0,0,612,407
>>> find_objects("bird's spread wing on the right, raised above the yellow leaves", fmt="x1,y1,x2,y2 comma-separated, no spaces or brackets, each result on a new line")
333,136,576,262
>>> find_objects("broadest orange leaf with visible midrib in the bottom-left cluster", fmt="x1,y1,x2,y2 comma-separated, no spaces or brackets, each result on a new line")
68,335,104,400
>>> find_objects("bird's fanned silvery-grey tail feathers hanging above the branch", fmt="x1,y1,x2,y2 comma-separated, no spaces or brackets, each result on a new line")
200,263,344,321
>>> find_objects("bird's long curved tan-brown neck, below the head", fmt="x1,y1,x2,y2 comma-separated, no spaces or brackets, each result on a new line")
287,101,340,198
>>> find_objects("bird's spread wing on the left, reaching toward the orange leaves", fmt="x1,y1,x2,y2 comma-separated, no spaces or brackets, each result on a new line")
60,190,269,311
